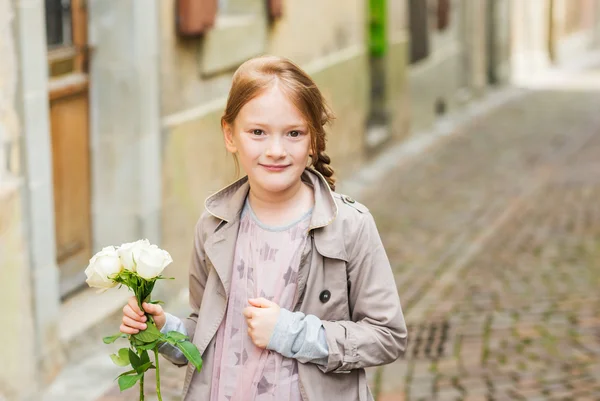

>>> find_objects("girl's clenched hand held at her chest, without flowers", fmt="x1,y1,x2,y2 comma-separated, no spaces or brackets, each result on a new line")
244,298,280,349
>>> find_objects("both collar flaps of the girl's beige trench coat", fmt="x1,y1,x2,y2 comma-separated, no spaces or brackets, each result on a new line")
204,168,338,231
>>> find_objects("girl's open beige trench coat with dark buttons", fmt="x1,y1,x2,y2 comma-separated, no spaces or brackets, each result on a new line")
176,169,407,401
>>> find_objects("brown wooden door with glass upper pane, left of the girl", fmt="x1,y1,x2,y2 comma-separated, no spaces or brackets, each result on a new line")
45,0,91,297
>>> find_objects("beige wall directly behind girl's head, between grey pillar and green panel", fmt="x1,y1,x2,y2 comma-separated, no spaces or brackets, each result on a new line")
160,0,369,287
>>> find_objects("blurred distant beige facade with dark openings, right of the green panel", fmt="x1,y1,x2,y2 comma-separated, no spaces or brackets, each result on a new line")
408,0,510,131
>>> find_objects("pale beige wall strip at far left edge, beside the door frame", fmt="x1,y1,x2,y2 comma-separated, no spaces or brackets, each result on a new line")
0,0,36,399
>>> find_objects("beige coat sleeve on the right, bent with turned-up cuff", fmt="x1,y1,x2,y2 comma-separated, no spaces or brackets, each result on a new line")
319,212,407,373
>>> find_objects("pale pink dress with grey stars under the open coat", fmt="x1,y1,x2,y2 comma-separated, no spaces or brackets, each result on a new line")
211,202,310,401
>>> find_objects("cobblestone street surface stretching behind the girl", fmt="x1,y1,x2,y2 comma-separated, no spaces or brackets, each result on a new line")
98,70,600,401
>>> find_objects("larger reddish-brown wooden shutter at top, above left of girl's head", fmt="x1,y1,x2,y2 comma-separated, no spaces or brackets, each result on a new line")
176,0,217,37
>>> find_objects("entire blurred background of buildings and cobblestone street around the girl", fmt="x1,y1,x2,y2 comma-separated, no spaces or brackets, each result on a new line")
0,0,600,401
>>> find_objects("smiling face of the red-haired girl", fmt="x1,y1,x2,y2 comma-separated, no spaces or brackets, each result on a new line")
223,85,310,194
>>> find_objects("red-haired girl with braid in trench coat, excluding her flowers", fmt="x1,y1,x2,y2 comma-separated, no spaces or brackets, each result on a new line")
121,57,407,401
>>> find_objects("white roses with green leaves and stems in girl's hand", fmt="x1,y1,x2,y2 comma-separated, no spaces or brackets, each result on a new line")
85,240,202,401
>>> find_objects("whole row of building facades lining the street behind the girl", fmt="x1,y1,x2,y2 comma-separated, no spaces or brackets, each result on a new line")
0,0,600,400
